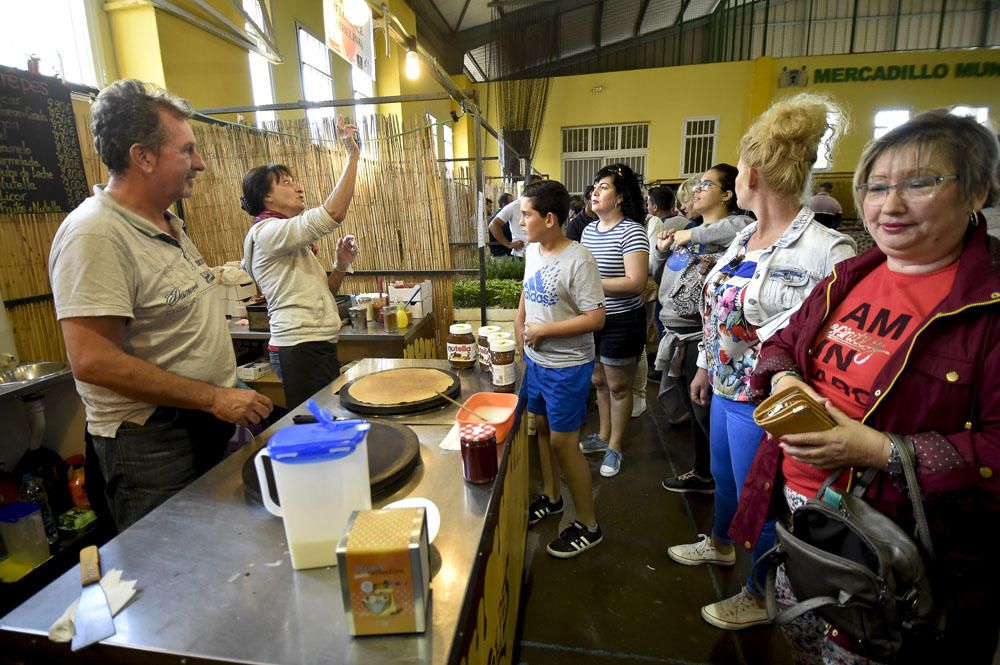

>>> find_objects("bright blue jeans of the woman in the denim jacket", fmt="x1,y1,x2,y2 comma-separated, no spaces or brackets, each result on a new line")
709,395,774,597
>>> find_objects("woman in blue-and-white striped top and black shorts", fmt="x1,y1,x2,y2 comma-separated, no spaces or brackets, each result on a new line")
580,164,649,478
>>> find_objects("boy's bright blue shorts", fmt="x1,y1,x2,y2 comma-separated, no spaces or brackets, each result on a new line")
524,357,594,432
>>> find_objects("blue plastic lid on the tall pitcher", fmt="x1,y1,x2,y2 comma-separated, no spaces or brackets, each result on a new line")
267,400,371,464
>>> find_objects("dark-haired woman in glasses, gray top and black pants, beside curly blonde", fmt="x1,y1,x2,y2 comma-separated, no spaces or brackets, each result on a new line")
649,164,753,494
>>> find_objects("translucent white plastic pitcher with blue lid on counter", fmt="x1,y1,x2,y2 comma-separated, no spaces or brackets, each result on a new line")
254,400,372,570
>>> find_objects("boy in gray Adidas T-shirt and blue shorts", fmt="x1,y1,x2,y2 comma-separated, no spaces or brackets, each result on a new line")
514,180,604,559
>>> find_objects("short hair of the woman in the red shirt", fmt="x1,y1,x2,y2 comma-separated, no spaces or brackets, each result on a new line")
854,109,1000,217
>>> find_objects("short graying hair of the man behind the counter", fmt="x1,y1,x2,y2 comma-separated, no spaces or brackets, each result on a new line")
90,79,194,173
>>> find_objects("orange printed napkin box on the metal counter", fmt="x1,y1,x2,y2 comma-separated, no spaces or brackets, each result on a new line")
337,508,430,635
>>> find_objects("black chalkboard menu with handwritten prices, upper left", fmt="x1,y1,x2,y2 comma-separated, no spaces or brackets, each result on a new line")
0,67,88,215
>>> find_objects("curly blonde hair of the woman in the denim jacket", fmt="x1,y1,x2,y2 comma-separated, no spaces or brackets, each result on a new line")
740,93,847,201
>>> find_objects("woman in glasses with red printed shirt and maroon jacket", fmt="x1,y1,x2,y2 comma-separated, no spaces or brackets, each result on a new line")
732,109,1000,663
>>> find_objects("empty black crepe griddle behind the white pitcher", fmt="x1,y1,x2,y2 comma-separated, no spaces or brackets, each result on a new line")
243,421,420,503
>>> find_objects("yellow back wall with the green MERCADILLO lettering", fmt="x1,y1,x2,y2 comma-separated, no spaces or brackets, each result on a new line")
532,49,1000,187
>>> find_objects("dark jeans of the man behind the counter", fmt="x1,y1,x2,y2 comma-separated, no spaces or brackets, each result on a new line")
92,406,235,531
